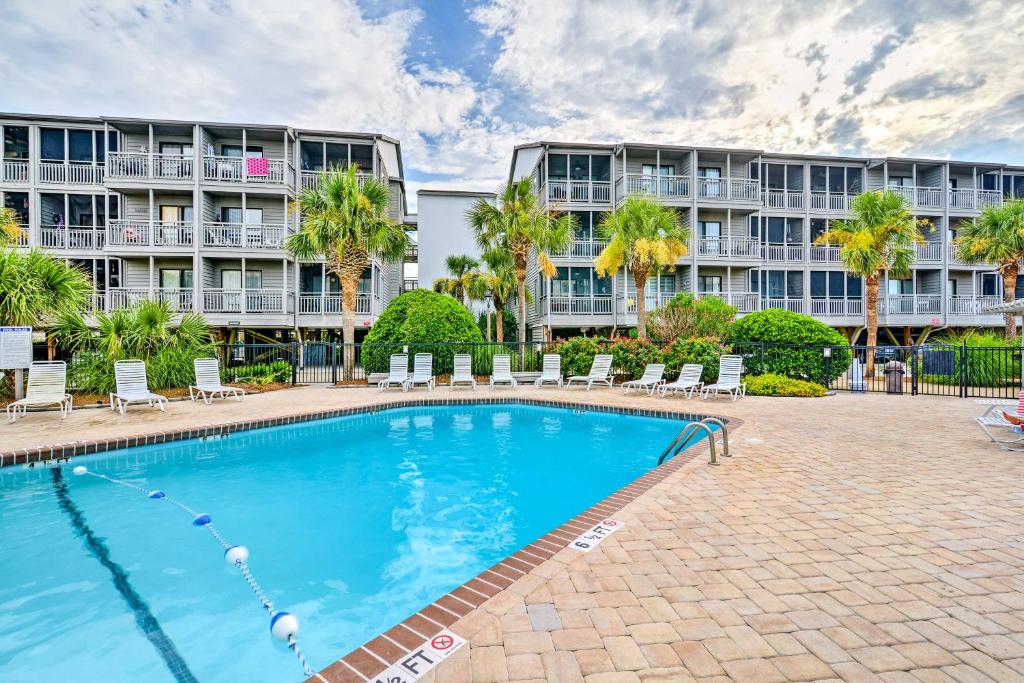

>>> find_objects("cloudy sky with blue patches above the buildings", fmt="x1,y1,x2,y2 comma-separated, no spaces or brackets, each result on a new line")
0,0,1024,206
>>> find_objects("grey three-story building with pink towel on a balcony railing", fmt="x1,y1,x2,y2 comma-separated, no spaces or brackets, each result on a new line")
0,114,406,348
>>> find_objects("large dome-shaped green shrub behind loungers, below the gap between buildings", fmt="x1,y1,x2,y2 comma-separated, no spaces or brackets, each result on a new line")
361,290,483,374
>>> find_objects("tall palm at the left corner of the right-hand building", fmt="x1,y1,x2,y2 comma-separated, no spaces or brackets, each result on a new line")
466,177,575,342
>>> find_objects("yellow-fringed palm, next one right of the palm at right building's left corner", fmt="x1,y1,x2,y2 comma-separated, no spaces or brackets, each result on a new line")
594,197,690,339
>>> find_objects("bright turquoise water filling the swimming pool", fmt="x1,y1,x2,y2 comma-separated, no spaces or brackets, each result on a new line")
0,404,681,683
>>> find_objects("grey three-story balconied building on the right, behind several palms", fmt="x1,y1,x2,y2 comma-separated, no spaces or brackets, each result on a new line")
509,142,1024,341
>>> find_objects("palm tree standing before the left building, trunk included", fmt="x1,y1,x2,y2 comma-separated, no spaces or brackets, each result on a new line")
285,166,409,379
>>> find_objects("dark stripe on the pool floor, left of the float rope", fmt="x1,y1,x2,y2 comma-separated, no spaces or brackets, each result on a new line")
50,467,199,683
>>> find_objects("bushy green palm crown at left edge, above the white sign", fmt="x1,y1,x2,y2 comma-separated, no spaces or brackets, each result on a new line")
0,249,92,326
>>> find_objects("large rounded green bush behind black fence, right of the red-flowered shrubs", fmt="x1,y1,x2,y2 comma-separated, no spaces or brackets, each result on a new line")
726,308,853,384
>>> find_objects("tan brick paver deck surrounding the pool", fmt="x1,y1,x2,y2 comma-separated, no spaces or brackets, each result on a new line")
6,388,1024,683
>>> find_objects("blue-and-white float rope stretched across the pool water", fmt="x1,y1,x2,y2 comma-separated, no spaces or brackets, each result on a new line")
69,465,316,680
